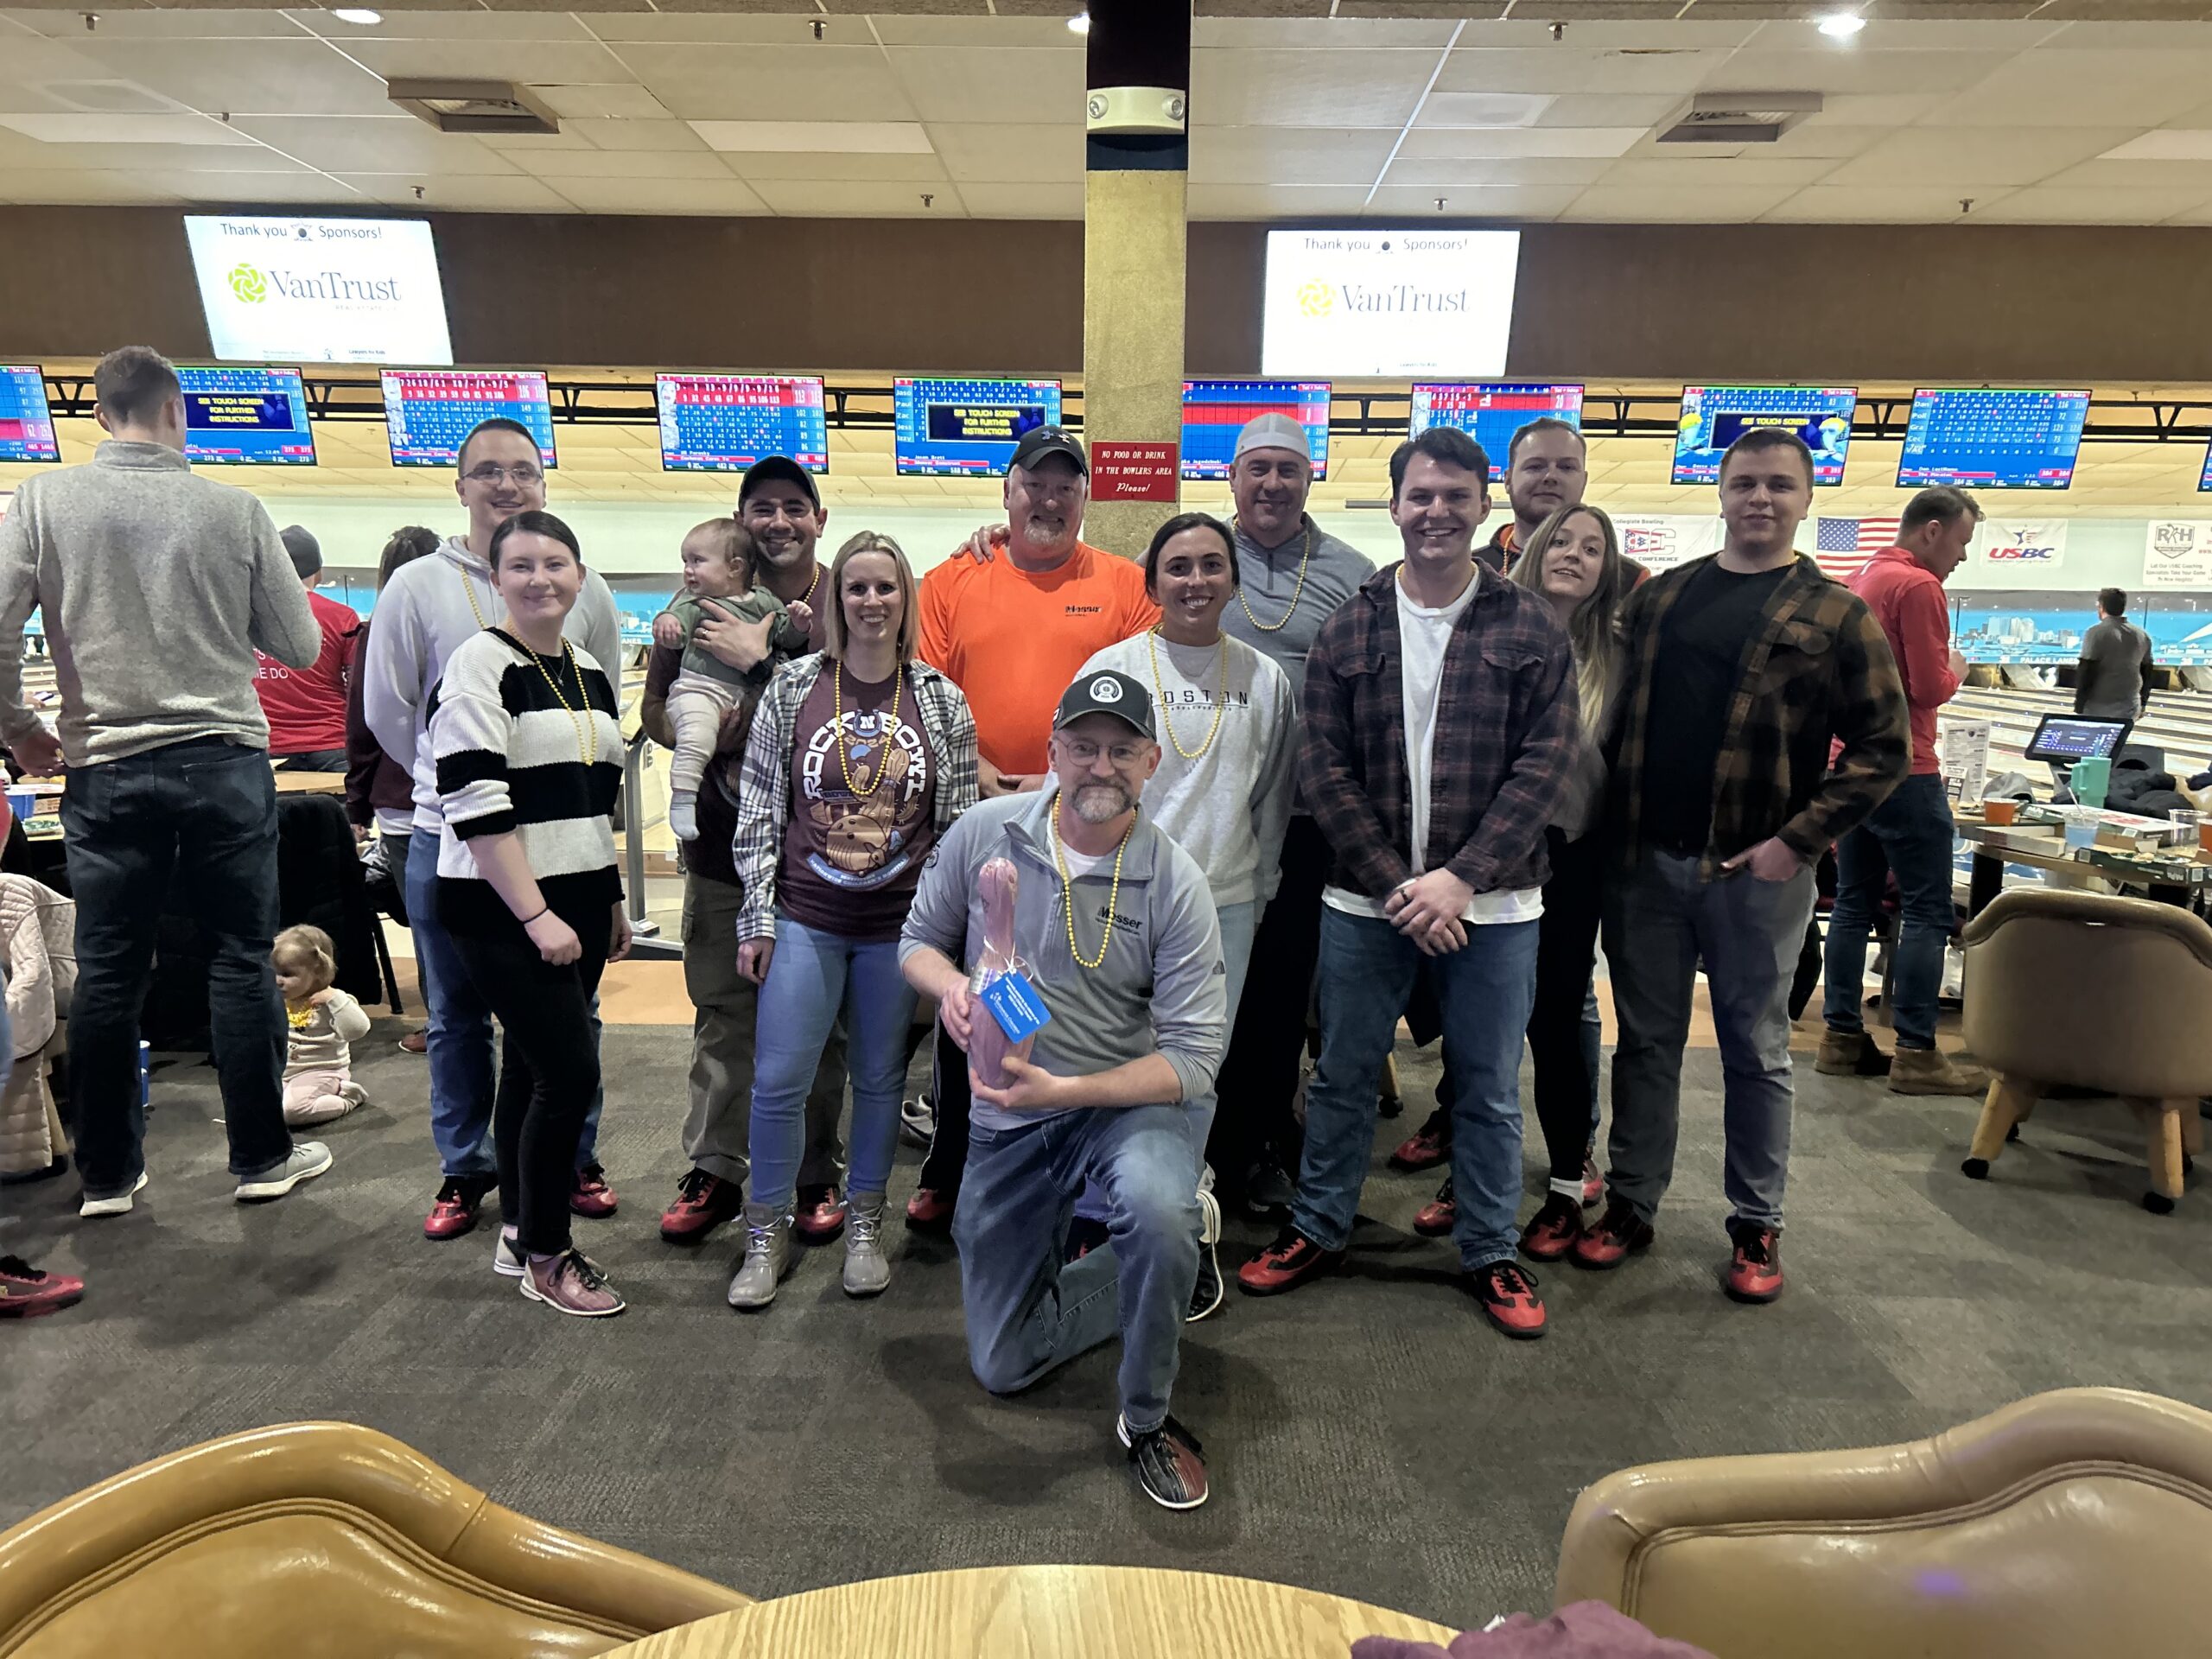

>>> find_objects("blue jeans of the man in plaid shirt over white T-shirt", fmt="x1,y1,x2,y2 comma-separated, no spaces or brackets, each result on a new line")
1289,909,1540,1272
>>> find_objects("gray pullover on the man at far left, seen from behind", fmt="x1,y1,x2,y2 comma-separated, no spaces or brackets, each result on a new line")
0,438,323,766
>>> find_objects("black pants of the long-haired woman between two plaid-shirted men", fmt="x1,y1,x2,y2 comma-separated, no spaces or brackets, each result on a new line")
1529,830,1606,1190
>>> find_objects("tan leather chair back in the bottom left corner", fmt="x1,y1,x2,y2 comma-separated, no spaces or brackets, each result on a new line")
0,1422,750,1659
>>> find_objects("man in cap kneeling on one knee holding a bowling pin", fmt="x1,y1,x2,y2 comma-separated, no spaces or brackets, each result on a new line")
898,671,1228,1509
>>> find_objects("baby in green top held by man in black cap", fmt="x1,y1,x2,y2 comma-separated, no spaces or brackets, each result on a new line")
652,518,814,841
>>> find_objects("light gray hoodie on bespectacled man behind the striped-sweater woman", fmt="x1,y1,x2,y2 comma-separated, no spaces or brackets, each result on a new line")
365,536,621,834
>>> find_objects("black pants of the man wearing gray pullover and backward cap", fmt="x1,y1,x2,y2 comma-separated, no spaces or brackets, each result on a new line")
1205,814,1330,1188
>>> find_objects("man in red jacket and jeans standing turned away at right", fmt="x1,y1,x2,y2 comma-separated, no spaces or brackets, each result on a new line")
1814,489,1988,1095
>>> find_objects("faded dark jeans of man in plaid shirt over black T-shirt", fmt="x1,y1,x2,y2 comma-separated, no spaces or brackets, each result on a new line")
1606,847,1814,1228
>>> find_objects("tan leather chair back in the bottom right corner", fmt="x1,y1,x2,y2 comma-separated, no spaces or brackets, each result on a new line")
1555,1389,2212,1659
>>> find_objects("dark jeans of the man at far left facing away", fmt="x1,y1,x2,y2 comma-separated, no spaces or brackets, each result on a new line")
62,736,292,1199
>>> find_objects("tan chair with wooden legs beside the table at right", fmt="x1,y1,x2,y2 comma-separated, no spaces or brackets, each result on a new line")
1960,887,2212,1214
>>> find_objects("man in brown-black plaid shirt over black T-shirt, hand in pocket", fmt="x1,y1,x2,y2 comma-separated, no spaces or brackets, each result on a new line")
1583,427,1911,1303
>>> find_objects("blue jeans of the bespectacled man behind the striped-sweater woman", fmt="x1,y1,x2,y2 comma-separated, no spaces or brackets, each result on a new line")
407,830,606,1185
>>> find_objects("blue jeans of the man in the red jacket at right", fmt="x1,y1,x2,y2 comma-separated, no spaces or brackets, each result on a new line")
1821,772,1958,1048
